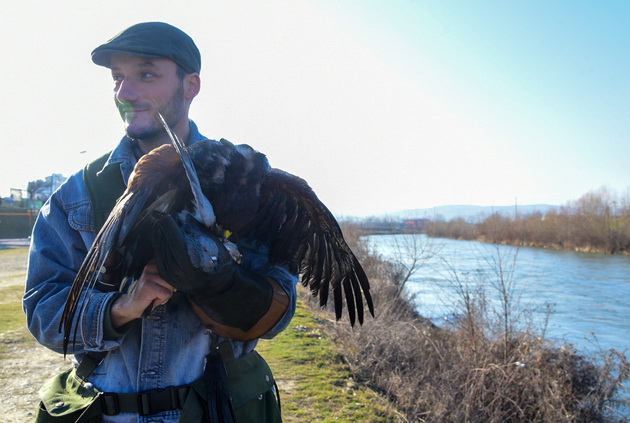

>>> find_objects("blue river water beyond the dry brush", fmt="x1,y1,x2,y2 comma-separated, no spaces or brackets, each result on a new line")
368,235,630,354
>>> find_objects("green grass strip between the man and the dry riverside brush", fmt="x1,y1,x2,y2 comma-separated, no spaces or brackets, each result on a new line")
258,302,398,422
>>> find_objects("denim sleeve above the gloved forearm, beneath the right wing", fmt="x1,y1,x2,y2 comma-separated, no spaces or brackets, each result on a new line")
241,240,299,339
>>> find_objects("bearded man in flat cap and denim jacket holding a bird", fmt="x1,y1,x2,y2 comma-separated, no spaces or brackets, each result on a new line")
23,22,297,422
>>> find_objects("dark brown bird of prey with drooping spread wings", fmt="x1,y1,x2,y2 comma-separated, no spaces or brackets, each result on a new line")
60,117,374,351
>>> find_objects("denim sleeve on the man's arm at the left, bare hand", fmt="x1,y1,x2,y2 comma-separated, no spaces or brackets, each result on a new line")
23,176,121,354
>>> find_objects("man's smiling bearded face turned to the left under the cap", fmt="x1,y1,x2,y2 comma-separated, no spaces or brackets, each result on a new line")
110,54,187,143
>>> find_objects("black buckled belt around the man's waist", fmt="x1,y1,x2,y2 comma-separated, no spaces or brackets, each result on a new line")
97,385,190,416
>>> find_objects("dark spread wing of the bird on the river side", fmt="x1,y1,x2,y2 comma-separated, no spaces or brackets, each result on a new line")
243,169,374,325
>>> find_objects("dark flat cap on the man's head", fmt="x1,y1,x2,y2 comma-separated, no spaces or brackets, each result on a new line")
92,22,201,73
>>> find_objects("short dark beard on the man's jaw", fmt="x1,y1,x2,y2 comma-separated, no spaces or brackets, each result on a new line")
118,84,184,144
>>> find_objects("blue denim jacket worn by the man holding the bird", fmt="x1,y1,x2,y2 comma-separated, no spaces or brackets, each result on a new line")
23,121,298,422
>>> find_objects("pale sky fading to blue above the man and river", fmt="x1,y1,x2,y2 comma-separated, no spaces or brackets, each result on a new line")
0,0,630,216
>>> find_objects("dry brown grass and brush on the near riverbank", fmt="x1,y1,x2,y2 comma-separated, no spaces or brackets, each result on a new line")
314,227,630,423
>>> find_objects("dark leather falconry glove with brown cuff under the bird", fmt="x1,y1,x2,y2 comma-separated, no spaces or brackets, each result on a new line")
153,212,289,340
